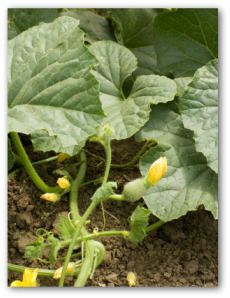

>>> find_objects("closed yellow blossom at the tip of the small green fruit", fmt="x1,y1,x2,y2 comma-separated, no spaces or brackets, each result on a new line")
146,157,167,186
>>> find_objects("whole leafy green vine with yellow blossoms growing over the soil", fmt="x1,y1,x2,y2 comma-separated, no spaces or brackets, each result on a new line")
8,9,218,287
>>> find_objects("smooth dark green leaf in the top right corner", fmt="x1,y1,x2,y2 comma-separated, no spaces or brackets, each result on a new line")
154,9,218,77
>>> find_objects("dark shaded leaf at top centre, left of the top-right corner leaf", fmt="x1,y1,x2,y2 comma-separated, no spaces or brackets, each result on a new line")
108,8,157,75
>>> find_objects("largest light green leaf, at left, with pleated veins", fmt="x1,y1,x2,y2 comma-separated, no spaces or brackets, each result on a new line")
8,17,103,154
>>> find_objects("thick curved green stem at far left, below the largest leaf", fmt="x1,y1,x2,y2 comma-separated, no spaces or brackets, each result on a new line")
10,132,60,193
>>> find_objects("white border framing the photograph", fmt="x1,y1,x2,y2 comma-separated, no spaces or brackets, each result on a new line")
0,0,230,298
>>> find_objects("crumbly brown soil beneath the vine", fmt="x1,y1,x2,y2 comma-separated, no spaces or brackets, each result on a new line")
8,139,218,287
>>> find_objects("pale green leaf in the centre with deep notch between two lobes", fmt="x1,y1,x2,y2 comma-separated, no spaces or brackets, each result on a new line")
90,41,176,139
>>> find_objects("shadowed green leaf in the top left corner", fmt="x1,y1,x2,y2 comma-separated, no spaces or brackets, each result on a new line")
8,8,58,39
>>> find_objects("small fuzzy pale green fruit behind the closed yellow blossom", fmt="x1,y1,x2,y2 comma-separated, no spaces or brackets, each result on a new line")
122,177,147,202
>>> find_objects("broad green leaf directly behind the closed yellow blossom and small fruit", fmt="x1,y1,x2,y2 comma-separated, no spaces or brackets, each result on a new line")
137,103,218,221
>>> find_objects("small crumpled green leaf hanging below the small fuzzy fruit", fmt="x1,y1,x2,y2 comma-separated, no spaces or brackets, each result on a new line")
129,206,151,244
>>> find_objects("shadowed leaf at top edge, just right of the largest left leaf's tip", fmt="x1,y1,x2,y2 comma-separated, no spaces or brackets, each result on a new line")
62,9,115,43
